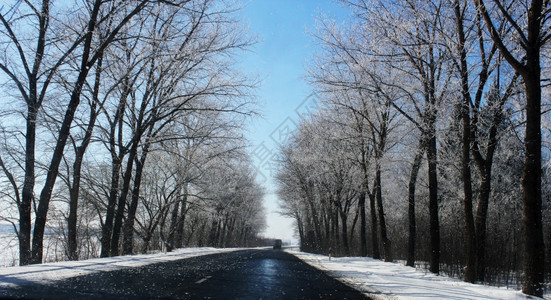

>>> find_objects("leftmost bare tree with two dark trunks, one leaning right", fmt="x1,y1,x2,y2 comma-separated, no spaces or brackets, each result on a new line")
0,0,157,264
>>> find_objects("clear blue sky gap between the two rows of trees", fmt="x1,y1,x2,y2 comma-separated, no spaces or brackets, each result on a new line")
238,0,348,241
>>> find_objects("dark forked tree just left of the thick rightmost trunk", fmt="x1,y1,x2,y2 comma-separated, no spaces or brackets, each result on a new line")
450,1,518,282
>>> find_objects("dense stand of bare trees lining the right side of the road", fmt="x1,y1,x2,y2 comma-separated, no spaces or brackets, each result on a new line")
276,0,551,297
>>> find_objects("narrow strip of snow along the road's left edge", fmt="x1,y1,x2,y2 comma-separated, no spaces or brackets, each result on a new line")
0,247,244,288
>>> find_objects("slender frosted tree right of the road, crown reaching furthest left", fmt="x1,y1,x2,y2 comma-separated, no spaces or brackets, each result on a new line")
310,23,406,261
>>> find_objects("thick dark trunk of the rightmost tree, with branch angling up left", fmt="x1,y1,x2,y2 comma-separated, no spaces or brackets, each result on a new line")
474,0,549,297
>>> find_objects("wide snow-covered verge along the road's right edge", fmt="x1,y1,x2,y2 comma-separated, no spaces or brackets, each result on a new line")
286,250,551,300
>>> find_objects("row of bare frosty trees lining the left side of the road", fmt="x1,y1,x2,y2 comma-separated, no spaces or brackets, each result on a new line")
0,0,264,265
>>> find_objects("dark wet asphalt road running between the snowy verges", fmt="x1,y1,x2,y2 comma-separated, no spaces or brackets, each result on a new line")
0,250,367,300
